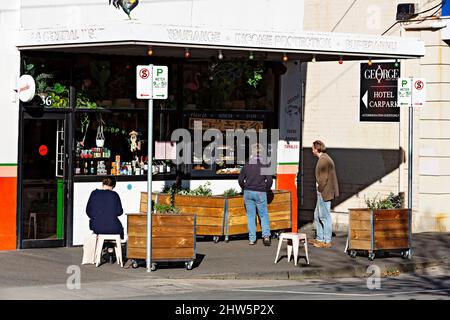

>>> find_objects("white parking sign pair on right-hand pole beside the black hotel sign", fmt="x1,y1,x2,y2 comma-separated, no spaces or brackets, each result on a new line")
398,78,427,107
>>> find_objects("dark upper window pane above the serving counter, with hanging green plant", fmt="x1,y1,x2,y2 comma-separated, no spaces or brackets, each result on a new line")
183,59,275,111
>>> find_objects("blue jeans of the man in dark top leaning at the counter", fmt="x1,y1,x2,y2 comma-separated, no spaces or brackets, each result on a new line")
244,190,270,241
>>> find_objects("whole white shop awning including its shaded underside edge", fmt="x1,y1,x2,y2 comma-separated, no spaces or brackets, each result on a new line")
17,22,425,61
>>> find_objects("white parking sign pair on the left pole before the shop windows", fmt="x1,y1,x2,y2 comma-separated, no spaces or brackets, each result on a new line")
136,65,169,100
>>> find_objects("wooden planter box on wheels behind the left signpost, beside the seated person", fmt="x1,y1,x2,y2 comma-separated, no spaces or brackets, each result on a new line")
127,213,196,270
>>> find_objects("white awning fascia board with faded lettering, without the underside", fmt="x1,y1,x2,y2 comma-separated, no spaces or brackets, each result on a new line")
17,22,425,58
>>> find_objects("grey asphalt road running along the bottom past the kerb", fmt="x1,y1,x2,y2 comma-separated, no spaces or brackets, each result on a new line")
0,266,450,300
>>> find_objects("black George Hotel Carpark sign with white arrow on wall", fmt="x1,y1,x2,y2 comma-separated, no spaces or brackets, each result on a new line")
359,63,400,122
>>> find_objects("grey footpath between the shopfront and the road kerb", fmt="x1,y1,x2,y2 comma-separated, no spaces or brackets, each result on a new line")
0,233,450,289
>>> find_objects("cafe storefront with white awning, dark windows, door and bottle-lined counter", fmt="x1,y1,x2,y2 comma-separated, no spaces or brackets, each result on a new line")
0,1,423,248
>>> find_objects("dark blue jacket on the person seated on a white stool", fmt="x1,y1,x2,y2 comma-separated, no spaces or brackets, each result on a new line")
86,189,123,239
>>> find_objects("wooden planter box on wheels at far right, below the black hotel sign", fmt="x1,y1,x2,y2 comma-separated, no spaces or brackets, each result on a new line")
348,209,411,260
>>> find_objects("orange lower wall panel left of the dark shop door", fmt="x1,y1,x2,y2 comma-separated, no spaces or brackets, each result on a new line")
0,178,17,250
